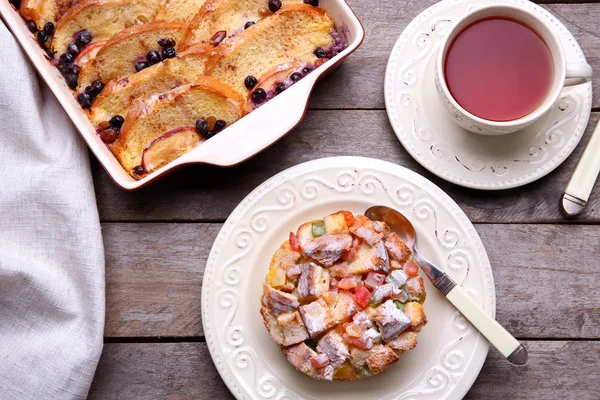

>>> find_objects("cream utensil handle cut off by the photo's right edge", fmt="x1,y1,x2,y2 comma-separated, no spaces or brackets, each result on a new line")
565,123,600,202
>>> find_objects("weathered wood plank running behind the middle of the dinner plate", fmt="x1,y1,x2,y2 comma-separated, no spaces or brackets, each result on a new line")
103,223,600,339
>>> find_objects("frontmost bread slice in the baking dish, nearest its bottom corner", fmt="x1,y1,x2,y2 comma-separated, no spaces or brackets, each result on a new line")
110,77,245,176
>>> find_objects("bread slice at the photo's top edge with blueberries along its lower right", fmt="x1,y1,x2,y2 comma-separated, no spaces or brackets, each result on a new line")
184,0,302,46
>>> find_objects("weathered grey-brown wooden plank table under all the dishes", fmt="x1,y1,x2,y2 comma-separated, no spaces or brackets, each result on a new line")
90,0,600,400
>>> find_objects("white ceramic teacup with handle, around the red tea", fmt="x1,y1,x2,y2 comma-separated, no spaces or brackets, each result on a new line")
435,4,592,135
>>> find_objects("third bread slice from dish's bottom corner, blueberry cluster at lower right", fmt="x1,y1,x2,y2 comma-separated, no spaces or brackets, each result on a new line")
77,22,188,92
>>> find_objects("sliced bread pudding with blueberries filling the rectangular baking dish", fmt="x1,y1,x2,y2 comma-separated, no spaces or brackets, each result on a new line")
10,0,346,179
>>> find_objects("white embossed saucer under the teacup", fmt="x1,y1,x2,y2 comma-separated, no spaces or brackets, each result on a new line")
385,0,592,190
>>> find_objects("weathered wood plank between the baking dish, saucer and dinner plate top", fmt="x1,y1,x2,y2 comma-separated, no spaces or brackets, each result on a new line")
93,110,600,222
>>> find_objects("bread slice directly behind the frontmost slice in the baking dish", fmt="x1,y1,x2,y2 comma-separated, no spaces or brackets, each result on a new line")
89,46,211,125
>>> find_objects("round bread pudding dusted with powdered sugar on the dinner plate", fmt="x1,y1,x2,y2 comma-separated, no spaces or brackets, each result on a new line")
260,211,427,381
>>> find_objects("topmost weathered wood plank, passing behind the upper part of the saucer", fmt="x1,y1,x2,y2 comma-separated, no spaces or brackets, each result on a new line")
310,0,600,108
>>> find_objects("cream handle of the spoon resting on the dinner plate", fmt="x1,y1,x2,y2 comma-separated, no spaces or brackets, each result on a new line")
446,285,527,365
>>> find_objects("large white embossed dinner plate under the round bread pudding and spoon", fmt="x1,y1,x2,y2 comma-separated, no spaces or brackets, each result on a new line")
202,157,495,400
